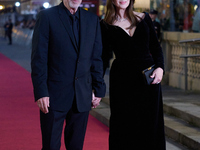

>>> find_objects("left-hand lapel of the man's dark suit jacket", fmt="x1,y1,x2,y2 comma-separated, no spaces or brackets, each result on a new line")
59,3,78,52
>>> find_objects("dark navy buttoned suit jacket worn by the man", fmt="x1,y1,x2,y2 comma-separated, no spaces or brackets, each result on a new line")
31,3,105,112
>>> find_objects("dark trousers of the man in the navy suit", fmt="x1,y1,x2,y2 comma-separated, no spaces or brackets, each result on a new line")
40,101,89,150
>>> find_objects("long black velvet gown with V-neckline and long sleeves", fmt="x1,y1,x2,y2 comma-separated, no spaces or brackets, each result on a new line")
101,13,165,150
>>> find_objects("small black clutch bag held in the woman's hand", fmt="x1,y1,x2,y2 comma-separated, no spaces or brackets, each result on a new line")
142,65,155,85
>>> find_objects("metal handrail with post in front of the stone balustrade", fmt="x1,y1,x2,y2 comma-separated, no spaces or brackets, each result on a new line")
179,38,200,91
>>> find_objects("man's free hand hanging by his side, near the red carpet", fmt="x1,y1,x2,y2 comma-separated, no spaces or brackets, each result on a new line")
37,97,50,114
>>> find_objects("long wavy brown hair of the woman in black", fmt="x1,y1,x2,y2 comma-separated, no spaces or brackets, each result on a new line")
104,0,139,29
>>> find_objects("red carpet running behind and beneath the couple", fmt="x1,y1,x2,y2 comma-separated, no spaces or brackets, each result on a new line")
0,54,108,150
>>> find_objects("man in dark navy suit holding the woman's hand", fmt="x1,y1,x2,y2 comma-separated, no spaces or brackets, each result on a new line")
31,0,105,150
